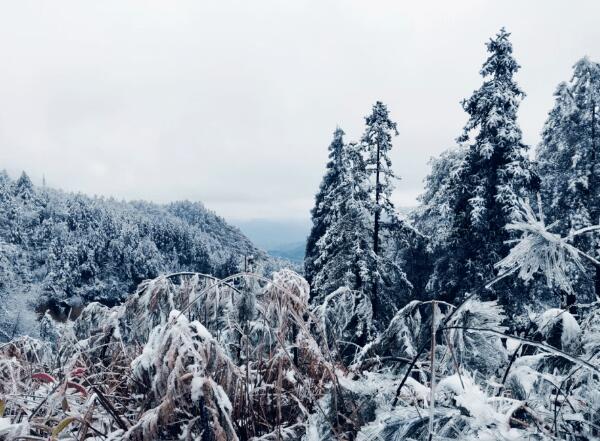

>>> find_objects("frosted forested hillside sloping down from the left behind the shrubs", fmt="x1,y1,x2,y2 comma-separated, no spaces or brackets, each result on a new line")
0,173,266,340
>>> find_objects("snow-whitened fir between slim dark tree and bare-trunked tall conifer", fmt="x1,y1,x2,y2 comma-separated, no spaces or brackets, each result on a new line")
313,143,379,303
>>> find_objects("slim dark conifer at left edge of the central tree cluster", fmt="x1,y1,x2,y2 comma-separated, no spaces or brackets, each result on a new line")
304,127,344,287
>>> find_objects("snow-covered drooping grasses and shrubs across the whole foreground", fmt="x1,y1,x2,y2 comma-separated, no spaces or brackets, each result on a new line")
0,201,600,441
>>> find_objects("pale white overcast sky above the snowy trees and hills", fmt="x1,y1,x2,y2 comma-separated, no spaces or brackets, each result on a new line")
0,0,600,219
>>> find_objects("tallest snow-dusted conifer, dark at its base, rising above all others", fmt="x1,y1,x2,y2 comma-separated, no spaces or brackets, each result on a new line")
430,28,535,304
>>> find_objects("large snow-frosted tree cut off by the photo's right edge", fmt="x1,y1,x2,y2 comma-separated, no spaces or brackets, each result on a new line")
537,58,600,296
